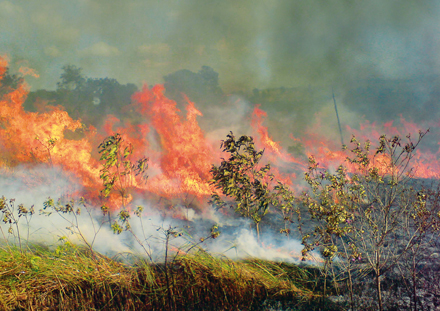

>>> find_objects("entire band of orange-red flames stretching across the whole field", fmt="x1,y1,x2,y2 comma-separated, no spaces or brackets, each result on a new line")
0,57,440,214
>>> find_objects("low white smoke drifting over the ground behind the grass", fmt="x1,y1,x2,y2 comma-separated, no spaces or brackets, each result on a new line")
0,165,312,262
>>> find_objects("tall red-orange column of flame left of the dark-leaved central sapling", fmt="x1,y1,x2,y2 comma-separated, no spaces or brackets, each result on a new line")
133,85,215,197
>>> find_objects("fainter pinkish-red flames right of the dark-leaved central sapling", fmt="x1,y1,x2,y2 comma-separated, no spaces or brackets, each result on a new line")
252,106,440,184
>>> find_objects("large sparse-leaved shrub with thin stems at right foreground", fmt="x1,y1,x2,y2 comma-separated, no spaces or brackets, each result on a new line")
302,132,439,310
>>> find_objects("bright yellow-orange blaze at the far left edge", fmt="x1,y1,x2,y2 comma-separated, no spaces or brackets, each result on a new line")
0,71,99,195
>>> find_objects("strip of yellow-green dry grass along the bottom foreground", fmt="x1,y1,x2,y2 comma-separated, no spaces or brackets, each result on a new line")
0,246,336,310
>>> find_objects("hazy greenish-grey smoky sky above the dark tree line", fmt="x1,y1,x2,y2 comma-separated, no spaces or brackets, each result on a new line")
0,0,440,90
